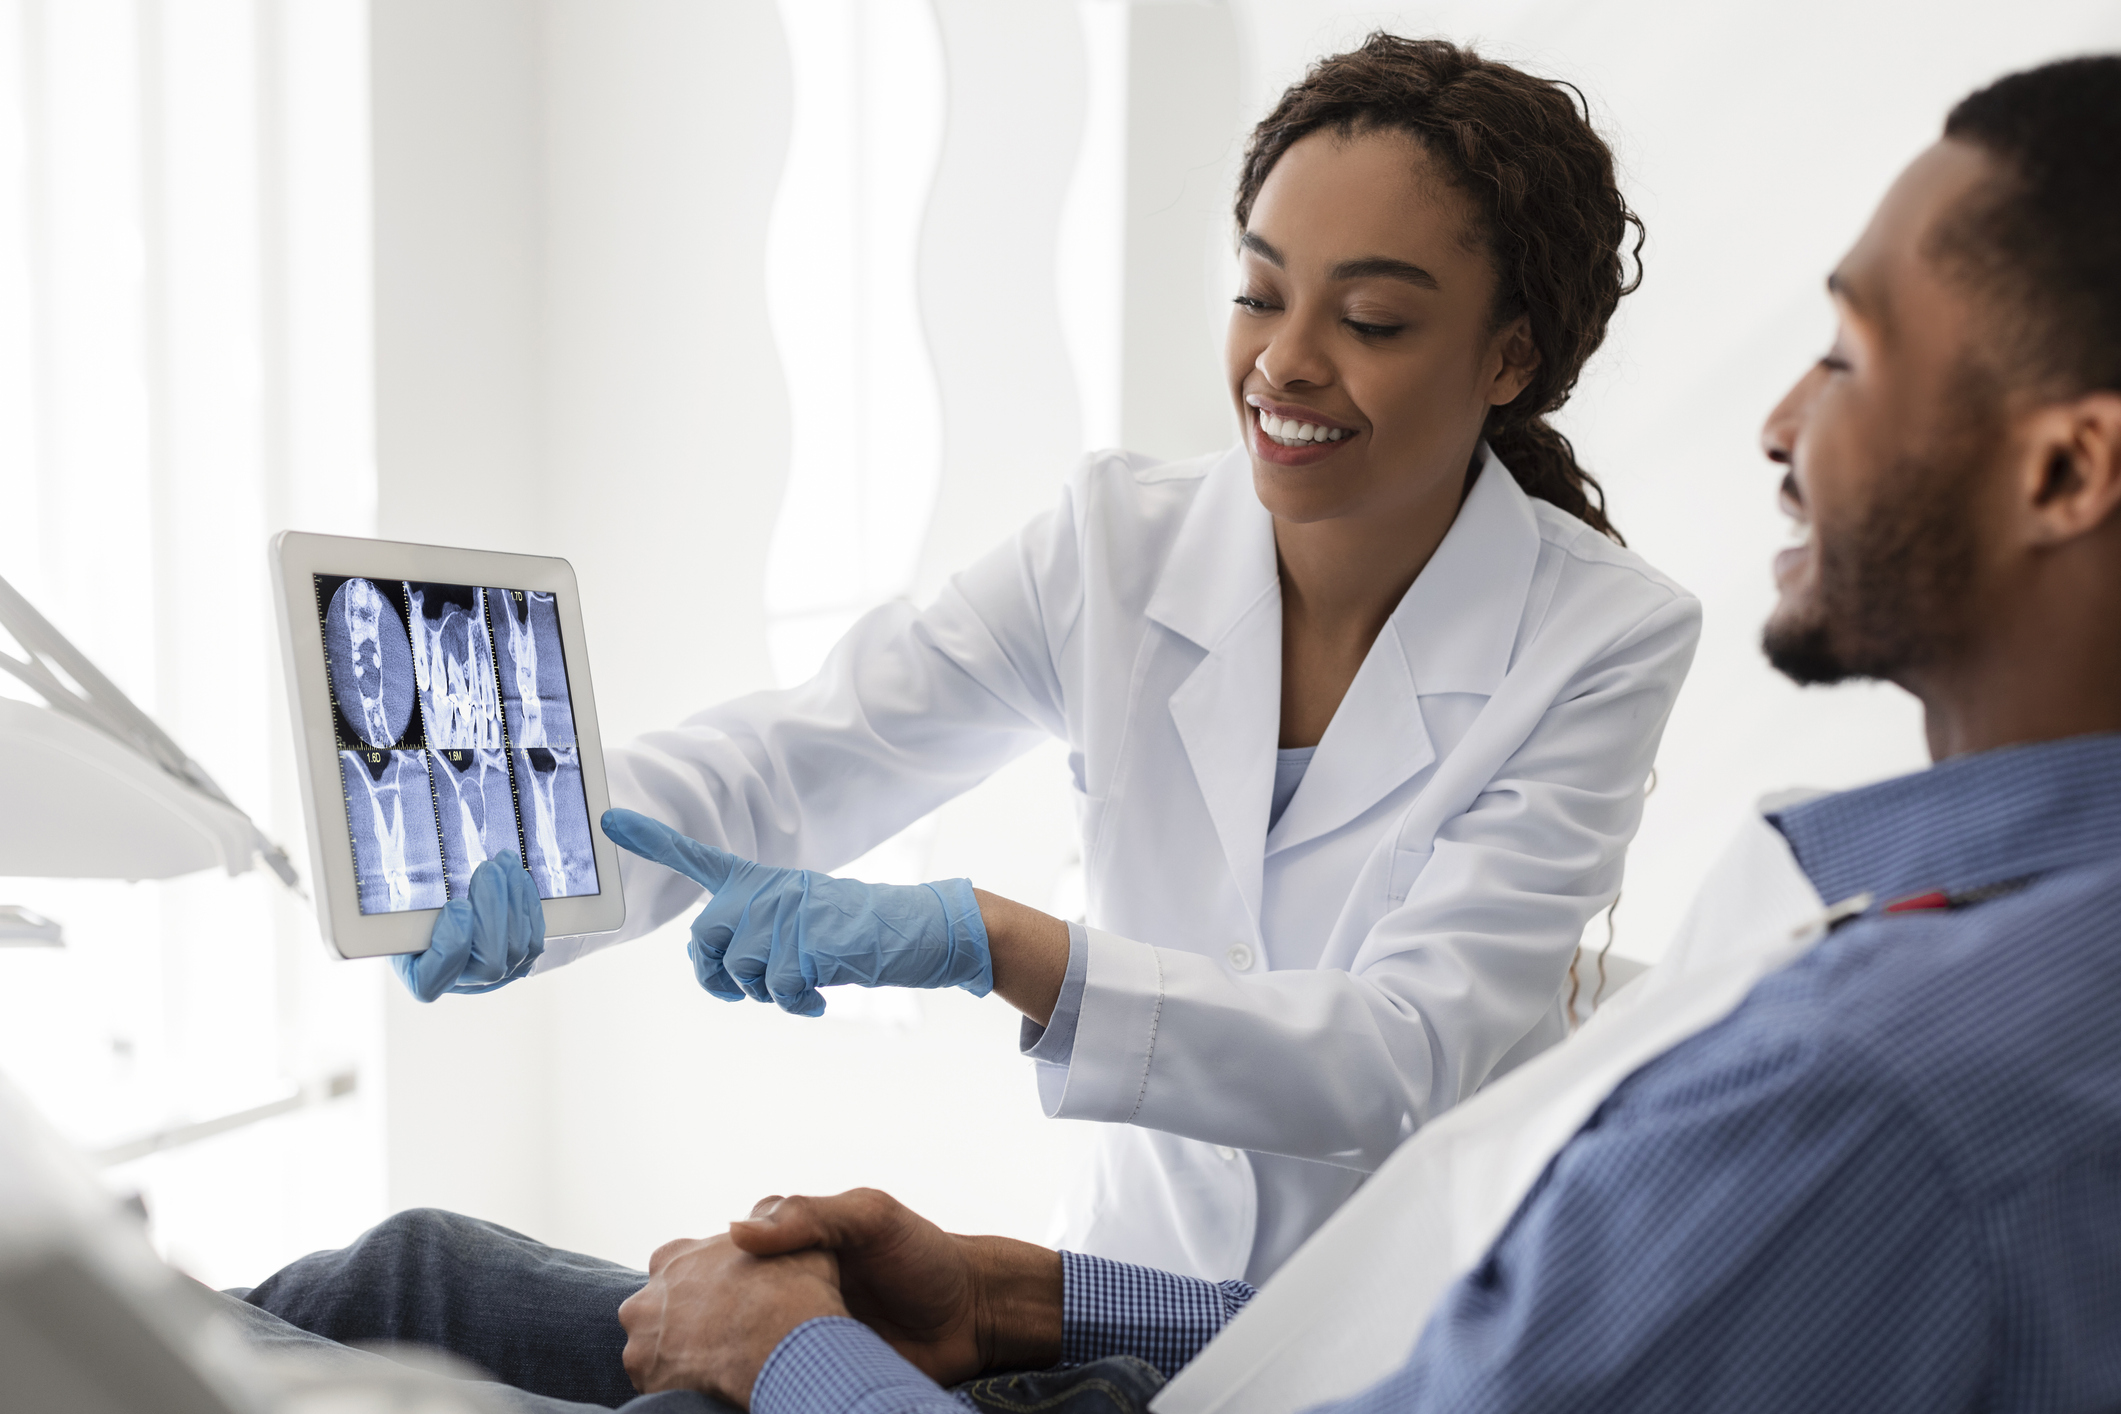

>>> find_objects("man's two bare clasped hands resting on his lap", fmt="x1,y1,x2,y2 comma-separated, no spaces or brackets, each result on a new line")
619,1189,1061,1410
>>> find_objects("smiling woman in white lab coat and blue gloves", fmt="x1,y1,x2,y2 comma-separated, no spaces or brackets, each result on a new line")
401,34,1699,1283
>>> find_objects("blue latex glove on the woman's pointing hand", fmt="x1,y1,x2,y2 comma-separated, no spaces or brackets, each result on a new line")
604,810,995,1015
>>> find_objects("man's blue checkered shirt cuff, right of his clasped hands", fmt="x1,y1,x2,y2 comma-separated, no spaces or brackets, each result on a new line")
1061,1253,1254,1380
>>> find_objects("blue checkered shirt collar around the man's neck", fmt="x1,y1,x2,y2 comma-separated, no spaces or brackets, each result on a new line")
1767,733,2121,903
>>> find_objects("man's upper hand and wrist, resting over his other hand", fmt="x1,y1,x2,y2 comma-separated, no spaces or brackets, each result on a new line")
730,1189,1063,1384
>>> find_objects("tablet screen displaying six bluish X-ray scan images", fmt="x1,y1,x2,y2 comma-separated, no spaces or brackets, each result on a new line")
314,575,598,914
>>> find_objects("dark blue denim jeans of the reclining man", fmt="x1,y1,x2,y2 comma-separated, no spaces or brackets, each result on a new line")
223,1208,1162,1414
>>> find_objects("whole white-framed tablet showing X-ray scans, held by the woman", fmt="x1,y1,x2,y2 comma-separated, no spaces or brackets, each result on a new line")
271,530,626,958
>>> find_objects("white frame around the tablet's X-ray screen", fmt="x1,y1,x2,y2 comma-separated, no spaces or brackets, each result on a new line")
271,530,626,958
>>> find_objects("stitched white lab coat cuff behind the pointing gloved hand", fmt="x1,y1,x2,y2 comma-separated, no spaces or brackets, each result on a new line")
1039,929,1164,1124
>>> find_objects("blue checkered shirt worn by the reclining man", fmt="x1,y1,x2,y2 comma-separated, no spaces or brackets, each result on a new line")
753,736,2121,1414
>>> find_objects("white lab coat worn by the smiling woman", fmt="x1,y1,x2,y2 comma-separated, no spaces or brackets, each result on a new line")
541,449,1699,1280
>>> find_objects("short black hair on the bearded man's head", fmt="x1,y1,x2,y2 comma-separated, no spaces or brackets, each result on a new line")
1936,55,2121,396
